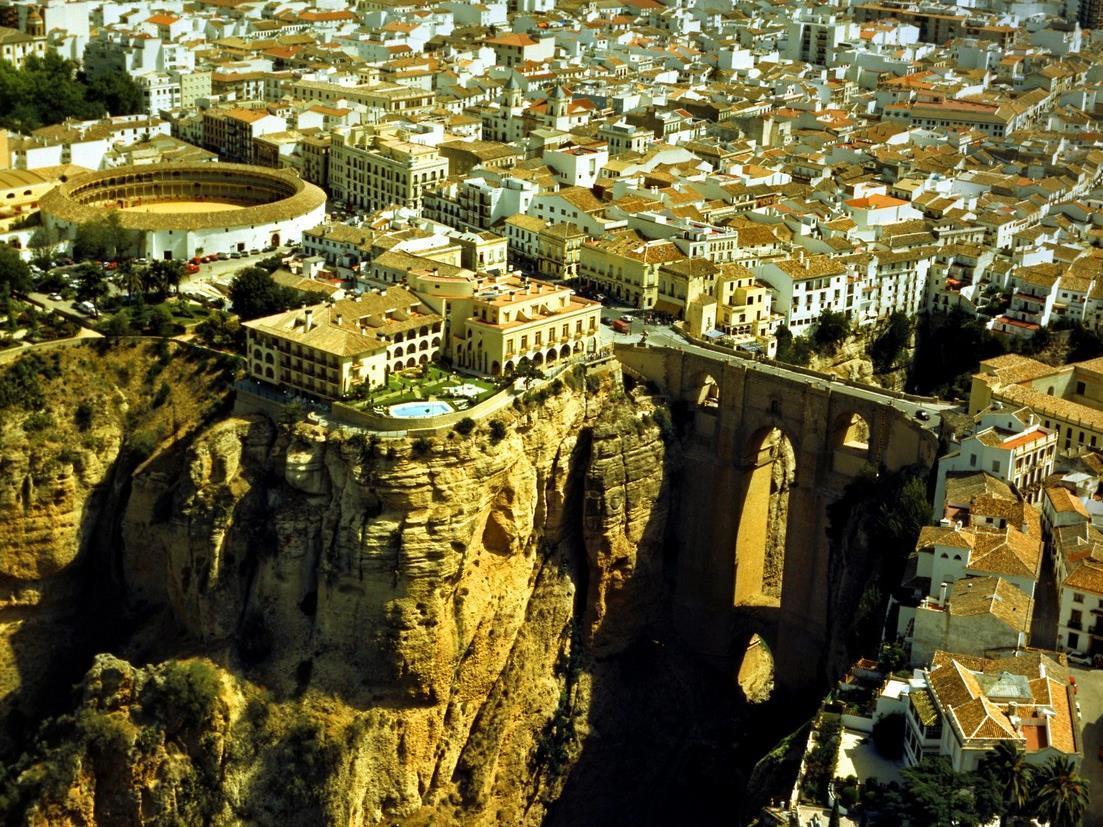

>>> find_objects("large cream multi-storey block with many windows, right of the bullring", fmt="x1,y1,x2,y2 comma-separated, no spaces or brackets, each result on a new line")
329,127,448,211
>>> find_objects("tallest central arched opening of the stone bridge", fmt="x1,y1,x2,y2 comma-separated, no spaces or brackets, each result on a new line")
732,428,796,606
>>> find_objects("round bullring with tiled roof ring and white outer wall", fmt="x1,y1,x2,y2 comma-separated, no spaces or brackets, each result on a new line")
40,163,325,259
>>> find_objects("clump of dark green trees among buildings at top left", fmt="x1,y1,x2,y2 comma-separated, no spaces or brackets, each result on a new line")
0,52,141,132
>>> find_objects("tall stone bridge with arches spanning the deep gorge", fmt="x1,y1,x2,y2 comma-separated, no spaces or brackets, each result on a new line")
617,343,947,687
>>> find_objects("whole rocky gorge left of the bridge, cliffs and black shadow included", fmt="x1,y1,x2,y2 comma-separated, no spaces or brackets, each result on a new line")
0,345,789,825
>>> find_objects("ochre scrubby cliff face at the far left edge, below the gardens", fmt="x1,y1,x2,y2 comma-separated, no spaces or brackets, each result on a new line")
0,343,232,750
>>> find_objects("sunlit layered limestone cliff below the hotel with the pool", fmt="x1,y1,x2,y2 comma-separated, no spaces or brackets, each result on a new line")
10,370,668,825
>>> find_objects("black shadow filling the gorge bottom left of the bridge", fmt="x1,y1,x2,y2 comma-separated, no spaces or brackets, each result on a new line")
545,421,811,827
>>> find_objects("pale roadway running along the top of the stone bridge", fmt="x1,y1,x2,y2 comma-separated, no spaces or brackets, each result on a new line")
601,308,957,431
